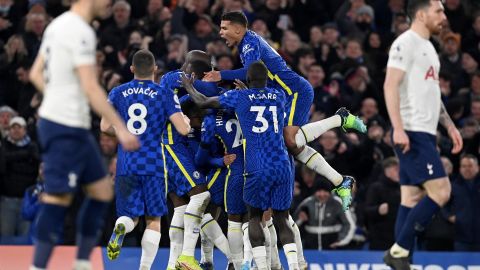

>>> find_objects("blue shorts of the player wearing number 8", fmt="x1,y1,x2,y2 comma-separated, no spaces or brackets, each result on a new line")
115,175,168,218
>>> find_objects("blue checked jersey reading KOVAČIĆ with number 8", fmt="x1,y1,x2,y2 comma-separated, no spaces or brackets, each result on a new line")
108,80,181,175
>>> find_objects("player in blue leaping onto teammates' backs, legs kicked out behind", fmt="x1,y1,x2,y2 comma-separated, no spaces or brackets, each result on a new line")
205,11,366,210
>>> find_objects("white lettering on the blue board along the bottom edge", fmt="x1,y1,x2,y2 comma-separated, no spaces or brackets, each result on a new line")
309,263,480,270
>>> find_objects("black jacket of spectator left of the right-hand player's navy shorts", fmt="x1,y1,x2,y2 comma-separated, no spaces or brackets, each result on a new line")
365,176,400,250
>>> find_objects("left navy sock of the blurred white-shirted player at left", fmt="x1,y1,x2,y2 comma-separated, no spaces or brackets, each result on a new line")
33,204,67,268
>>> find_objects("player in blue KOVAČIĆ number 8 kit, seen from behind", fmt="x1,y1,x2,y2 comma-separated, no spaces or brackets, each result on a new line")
101,50,190,270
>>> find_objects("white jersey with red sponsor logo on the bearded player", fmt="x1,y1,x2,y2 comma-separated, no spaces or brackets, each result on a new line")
387,30,441,135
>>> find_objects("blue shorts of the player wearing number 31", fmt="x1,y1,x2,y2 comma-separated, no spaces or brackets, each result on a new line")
243,164,293,211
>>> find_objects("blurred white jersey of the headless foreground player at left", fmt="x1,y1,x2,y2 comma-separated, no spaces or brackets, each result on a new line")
39,11,96,129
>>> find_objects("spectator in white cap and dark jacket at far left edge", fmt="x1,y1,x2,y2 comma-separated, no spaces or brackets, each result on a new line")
0,116,39,237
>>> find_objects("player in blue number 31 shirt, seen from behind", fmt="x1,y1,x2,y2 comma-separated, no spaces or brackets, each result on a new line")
182,62,298,270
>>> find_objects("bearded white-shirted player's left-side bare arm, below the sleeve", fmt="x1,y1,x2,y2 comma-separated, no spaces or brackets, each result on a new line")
383,68,405,130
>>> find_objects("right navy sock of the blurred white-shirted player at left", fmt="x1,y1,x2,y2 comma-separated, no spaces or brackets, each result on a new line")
77,198,110,260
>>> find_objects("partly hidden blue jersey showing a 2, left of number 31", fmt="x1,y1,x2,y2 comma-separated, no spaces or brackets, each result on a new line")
202,110,244,175
